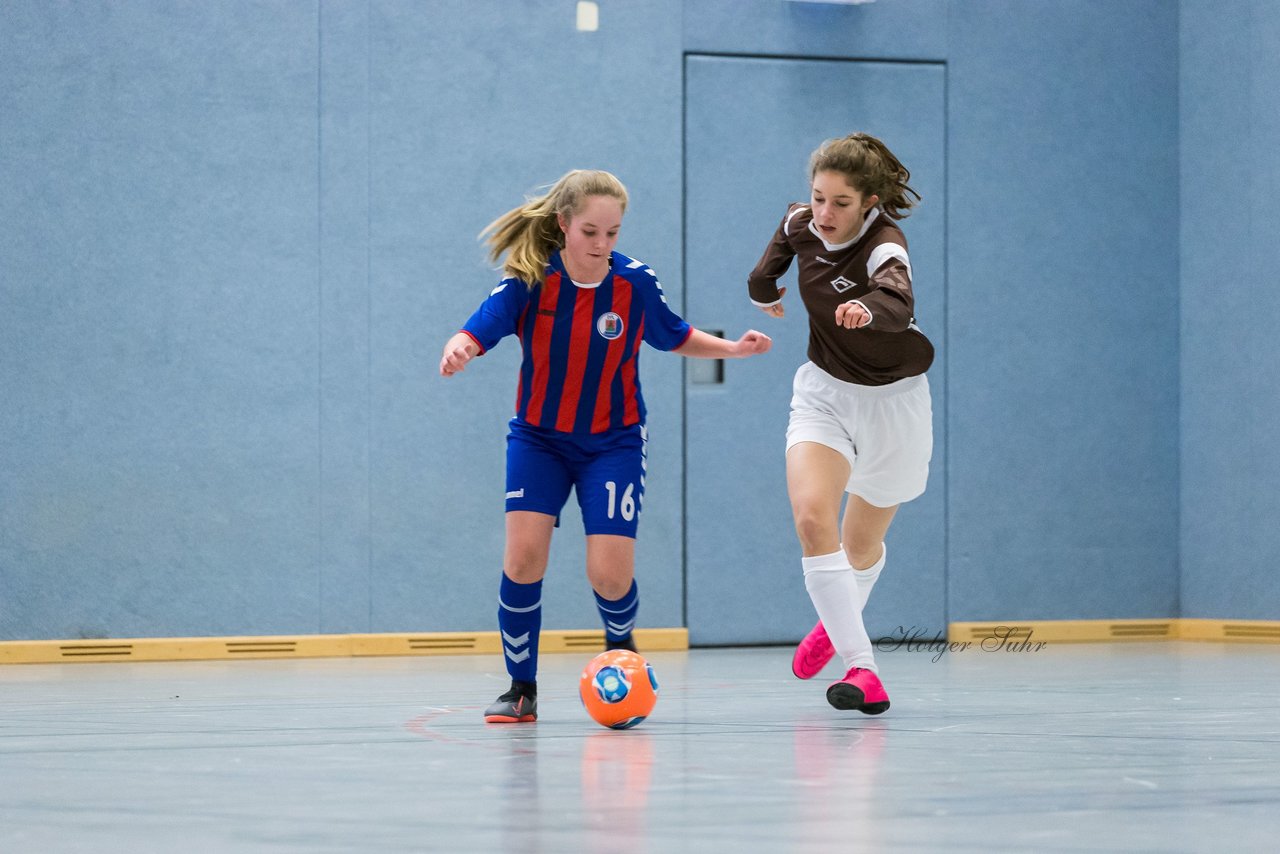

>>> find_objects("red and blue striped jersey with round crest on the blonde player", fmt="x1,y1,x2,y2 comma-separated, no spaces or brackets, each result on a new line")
462,252,692,434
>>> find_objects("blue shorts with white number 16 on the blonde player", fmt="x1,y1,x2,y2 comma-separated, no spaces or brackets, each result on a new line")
507,419,648,539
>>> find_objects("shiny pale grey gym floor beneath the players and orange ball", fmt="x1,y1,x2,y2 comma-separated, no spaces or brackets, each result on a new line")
0,643,1280,854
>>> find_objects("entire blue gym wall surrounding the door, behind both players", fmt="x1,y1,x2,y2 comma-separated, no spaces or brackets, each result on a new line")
0,0,1280,639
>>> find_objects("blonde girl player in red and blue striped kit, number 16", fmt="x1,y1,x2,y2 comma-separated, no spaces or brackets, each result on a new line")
440,170,772,723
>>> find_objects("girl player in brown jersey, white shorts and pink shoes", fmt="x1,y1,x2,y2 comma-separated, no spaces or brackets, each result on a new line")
748,133,933,714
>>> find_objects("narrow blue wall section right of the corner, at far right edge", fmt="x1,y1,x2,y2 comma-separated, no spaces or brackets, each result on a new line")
1179,0,1280,620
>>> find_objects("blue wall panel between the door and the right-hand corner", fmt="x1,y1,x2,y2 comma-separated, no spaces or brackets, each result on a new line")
947,0,1179,621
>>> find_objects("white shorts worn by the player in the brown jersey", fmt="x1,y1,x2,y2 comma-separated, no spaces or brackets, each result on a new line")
787,362,933,507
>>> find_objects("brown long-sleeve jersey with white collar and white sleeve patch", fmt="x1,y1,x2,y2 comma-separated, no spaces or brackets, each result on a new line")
748,204,933,385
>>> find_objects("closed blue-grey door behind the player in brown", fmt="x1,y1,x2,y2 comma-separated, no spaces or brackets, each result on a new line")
685,55,946,644
